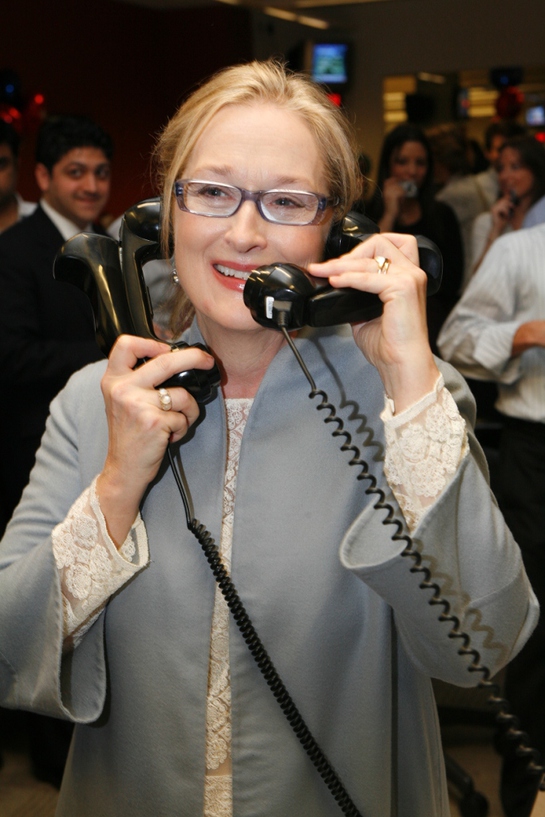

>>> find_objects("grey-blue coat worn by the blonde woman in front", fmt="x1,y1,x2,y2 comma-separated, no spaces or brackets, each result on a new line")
0,328,537,817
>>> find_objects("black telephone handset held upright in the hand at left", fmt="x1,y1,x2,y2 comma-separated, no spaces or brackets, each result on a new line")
53,199,220,403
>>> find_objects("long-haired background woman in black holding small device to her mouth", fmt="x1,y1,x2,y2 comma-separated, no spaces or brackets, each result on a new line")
368,124,464,353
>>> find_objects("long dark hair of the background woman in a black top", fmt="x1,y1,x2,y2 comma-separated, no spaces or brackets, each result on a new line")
366,124,433,221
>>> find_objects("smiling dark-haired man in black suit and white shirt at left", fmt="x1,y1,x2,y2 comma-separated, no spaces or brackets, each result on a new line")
0,116,112,785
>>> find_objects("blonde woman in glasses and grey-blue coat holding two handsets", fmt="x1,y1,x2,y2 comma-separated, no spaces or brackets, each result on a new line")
0,63,536,817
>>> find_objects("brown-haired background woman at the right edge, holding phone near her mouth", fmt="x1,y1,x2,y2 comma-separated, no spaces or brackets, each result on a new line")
472,136,545,273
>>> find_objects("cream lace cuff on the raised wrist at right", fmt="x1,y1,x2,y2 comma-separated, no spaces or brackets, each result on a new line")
380,375,469,533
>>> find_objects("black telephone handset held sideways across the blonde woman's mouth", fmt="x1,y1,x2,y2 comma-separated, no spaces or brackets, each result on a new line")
244,213,443,330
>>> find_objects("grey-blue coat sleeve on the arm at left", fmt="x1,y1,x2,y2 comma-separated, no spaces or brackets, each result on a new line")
0,367,117,722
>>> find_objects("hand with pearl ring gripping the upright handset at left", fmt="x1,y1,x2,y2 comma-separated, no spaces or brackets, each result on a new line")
97,335,214,546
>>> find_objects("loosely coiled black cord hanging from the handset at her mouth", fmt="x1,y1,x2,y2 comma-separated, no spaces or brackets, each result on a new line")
281,327,545,791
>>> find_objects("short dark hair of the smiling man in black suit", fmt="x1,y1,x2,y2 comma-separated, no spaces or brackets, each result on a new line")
36,114,113,173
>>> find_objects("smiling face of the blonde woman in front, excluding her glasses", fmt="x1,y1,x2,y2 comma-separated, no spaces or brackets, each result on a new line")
174,103,331,336
